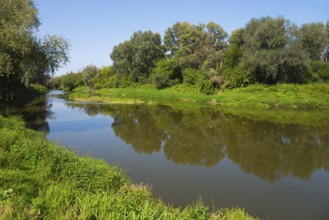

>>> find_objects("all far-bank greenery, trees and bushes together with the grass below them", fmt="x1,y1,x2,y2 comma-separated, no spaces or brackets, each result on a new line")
50,17,329,107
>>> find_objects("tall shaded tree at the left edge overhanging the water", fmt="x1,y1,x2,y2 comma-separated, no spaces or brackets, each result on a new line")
0,0,69,101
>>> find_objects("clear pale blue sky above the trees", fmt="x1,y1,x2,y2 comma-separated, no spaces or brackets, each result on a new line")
35,0,329,75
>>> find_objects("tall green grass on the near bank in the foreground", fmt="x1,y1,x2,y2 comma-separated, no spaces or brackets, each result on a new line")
0,116,253,219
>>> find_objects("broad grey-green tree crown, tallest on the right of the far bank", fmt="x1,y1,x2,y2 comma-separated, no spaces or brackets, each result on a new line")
242,17,310,84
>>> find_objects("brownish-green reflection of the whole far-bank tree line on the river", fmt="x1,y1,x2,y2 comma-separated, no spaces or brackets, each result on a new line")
68,103,329,182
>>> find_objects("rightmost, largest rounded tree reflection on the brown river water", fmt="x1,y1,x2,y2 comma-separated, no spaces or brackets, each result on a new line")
225,120,329,181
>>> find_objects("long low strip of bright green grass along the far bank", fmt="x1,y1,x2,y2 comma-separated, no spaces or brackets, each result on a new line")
69,84,329,108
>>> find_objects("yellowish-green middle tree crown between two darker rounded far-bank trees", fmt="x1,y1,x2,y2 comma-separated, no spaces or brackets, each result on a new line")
164,22,227,70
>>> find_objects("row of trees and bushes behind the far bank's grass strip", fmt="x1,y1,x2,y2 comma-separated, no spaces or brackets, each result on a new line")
55,17,329,94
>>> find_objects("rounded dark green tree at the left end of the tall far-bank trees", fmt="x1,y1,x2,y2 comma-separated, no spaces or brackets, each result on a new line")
110,31,164,82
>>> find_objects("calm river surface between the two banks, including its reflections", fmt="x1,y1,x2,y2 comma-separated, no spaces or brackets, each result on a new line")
2,91,329,220
